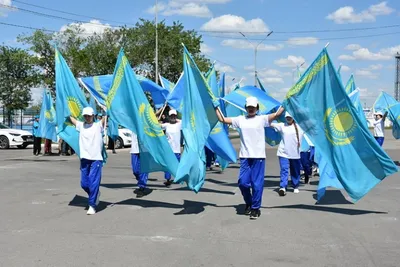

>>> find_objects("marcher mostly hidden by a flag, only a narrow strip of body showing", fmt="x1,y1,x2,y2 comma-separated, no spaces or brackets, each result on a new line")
131,132,151,198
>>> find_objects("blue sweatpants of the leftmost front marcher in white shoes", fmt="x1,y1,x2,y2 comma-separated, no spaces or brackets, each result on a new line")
81,159,103,208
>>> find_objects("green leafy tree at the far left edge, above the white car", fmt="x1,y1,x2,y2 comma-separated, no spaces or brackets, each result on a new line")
0,46,39,126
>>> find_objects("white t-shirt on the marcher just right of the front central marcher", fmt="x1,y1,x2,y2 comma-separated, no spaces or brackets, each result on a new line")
271,123,304,159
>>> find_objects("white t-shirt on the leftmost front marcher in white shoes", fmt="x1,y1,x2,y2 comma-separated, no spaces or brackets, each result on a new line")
76,121,103,160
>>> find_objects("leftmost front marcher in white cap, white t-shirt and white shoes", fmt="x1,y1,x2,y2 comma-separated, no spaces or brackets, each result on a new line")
70,107,105,215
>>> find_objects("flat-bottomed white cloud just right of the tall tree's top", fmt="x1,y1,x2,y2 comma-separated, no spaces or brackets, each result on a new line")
201,14,269,32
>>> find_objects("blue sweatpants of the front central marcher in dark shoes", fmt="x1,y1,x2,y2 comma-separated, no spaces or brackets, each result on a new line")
239,158,265,209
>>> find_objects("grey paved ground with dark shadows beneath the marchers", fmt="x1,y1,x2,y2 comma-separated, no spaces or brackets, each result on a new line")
0,130,400,267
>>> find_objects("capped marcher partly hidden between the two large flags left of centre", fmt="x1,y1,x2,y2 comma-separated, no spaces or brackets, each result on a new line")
161,109,182,187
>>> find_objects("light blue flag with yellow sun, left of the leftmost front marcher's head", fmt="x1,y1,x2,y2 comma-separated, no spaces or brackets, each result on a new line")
55,49,89,156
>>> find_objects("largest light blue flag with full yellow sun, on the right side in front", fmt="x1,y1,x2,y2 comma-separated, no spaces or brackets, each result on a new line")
284,48,397,201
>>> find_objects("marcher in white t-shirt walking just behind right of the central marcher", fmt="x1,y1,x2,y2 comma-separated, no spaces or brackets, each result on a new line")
271,112,303,196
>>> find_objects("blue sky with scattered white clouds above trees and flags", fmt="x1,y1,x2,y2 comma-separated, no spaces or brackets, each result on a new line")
0,0,400,107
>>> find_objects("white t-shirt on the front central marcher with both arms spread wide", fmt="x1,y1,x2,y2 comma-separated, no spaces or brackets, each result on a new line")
232,115,269,159
